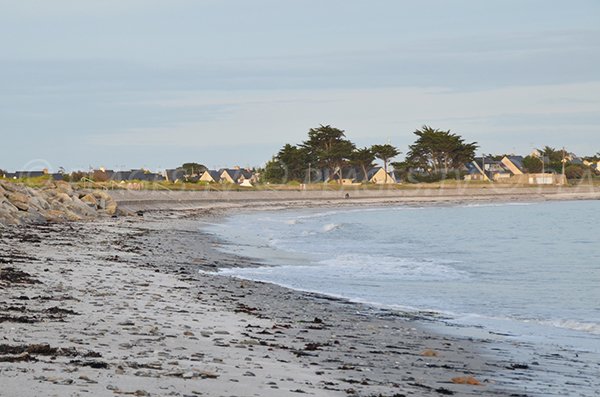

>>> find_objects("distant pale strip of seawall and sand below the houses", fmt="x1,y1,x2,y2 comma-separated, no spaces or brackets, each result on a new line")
110,186,600,211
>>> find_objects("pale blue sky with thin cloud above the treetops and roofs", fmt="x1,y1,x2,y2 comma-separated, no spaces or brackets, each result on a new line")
0,0,600,171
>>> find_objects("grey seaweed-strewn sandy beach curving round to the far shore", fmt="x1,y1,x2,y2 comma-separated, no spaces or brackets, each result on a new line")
0,191,600,396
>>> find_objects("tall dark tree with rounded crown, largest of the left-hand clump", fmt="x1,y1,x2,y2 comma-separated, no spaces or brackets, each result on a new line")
301,124,355,181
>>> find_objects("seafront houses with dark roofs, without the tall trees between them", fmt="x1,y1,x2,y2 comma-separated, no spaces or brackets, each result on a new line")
0,151,600,188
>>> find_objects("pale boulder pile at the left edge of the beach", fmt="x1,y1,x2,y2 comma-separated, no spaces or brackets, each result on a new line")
0,180,118,225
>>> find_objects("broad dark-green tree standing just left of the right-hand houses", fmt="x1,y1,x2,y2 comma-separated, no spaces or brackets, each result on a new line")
407,125,478,175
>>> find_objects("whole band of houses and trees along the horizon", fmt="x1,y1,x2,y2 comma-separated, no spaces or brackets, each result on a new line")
0,125,600,190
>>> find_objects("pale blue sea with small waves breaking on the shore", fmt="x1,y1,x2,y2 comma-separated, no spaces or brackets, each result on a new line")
207,201,600,353
